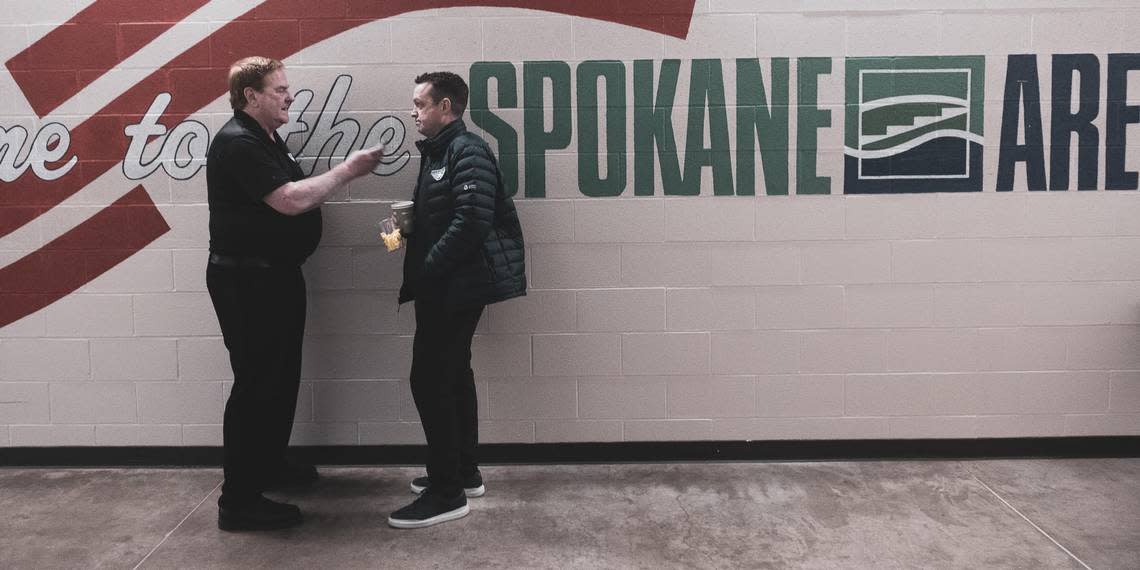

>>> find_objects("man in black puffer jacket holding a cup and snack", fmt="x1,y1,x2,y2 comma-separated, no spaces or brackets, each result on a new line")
388,72,527,528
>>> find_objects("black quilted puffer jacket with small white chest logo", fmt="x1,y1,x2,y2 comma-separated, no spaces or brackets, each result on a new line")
400,120,527,310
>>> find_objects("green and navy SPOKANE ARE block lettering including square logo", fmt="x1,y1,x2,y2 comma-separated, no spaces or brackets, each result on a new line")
470,54,1140,197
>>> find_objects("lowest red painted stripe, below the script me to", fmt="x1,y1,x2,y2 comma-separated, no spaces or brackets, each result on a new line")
0,186,170,327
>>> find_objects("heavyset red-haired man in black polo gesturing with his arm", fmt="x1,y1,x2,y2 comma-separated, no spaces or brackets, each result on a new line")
206,57,383,530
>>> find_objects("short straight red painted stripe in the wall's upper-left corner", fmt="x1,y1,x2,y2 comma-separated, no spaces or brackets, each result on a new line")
5,0,210,116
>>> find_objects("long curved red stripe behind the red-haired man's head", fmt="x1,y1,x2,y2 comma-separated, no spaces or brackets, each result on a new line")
0,0,695,236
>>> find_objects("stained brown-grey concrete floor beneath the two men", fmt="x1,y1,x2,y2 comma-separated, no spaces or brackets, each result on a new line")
0,458,1140,570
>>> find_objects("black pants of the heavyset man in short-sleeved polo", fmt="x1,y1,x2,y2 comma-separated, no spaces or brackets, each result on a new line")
206,263,306,503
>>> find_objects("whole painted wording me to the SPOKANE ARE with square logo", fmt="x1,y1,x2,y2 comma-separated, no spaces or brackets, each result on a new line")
0,55,1140,197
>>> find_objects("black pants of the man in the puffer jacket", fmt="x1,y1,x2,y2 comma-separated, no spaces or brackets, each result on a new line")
412,300,483,496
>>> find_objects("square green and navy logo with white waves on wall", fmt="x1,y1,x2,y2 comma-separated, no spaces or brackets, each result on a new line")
844,56,986,194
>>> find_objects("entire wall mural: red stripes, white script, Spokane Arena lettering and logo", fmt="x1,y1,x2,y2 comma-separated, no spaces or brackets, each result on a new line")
0,0,1140,326
